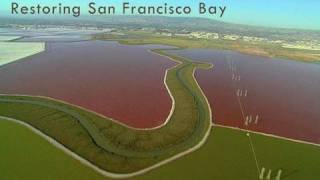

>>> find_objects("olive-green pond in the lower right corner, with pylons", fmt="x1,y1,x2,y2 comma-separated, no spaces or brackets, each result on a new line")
138,127,320,180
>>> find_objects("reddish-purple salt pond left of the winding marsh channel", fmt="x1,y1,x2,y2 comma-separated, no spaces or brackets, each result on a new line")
0,41,174,128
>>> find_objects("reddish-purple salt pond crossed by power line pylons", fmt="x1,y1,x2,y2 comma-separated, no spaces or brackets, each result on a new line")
170,49,320,144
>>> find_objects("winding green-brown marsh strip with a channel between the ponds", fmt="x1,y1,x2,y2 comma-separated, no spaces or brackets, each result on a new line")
0,50,211,173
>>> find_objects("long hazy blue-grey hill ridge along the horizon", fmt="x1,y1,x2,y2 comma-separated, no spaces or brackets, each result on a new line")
0,16,320,41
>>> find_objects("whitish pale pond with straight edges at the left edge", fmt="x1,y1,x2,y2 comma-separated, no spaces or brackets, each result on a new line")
0,41,45,66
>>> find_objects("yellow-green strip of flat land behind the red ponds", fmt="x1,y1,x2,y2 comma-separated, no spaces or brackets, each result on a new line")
93,30,320,62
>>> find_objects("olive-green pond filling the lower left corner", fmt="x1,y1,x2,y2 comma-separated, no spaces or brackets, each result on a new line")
0,118,103,180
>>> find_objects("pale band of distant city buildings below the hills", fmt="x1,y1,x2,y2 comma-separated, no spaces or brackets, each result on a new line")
4,21,320,50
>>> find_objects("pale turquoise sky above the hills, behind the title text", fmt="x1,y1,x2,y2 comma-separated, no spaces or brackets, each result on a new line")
0,0,320,30
